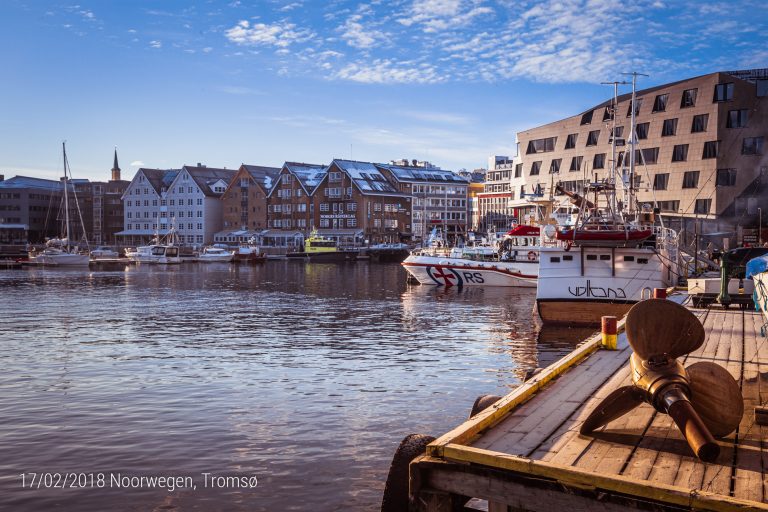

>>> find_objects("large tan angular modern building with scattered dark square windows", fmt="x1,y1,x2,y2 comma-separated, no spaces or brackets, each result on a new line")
512,69,768,248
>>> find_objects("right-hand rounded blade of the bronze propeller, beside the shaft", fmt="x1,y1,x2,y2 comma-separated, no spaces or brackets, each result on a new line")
685,361,744,437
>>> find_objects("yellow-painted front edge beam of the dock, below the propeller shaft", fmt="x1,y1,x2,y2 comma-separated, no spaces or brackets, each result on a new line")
443,444,768,512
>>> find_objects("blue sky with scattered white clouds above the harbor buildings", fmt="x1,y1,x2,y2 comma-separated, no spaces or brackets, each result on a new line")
0,0,768,180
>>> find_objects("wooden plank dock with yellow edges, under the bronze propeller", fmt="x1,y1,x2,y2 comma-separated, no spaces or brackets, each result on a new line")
410,302,768,512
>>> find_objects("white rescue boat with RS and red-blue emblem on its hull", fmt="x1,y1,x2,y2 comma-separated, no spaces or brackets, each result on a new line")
401,225,540,288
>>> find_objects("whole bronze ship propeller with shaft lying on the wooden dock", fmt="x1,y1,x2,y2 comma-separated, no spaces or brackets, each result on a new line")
580,299,744,462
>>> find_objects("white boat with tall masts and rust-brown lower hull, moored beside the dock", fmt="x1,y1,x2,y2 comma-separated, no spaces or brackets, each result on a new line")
536,76,678,326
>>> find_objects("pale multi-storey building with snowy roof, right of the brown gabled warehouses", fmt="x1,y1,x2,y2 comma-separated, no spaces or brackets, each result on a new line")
375,160,469,242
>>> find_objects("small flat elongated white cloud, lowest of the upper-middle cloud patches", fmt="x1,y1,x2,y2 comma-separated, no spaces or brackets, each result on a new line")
335,59,444,84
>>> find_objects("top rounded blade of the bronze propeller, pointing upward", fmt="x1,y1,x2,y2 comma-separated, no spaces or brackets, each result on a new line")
625,299,704,361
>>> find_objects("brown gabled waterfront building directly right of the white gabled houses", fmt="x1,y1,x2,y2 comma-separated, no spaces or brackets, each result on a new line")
214,164,280,243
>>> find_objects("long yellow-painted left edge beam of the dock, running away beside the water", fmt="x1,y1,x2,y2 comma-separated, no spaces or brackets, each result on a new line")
427,318,624,457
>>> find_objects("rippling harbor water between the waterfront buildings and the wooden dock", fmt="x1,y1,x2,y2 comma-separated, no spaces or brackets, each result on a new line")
0,261,586,511
